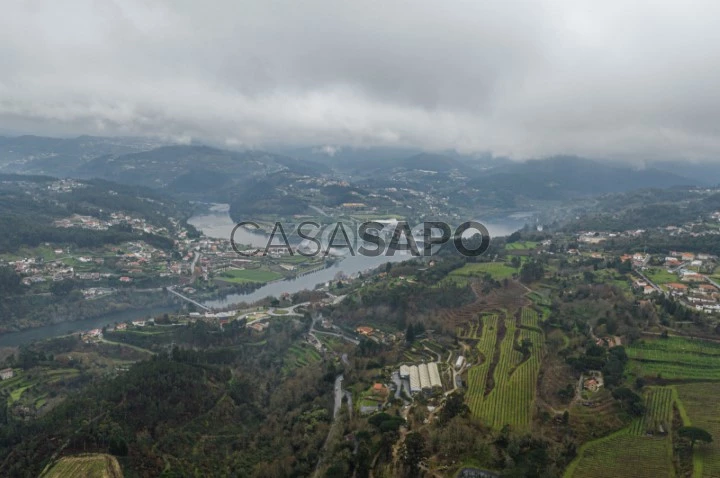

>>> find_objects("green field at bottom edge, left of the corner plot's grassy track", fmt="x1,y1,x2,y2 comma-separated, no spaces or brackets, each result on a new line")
564,425,675,478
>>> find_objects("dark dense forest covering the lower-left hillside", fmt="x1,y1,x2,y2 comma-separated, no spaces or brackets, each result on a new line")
0,322,336,478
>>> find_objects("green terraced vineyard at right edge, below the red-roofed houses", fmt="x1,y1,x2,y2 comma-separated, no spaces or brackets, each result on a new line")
627,337,720,380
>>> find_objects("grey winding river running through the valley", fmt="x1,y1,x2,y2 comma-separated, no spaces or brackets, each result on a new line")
0,204,527,346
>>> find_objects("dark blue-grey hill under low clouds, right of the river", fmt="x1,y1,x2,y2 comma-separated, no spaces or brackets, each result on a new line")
469,156,698,200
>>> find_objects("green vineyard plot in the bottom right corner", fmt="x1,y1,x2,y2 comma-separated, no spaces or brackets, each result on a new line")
675,383,720,477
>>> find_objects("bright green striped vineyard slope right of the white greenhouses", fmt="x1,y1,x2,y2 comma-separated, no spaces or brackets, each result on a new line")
468,308,545,429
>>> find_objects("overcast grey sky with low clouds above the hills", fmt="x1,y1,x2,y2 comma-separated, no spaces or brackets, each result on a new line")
0,0,720,159
